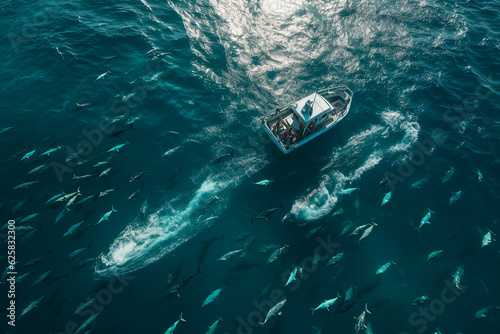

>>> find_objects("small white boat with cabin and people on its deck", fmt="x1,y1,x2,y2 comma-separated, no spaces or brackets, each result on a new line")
262,86,353,154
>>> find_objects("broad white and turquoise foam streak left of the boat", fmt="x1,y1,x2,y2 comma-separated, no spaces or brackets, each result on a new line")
95,180,227,276
